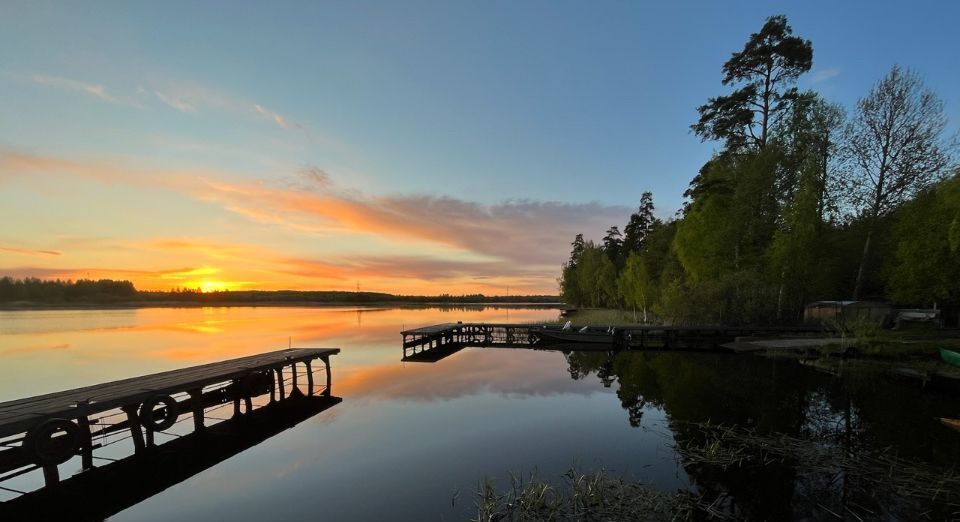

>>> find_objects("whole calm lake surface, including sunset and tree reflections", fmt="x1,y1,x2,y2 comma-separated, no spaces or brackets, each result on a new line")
0,307,960,521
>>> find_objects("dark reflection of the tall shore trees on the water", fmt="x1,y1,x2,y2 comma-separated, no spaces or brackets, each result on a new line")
565,352,960,520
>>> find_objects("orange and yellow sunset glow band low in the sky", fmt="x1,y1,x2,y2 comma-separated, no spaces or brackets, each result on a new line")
0,147,621,294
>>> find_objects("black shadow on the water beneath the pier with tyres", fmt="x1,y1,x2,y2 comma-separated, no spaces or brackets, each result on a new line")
0,395,343,520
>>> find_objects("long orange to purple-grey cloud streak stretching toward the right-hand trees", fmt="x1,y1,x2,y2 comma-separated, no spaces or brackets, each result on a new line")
197,174,630,266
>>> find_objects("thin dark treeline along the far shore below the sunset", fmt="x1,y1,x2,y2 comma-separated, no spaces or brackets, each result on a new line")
0,277,560,305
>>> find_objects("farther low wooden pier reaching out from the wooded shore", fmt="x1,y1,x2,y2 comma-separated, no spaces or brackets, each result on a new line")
400,323,824,362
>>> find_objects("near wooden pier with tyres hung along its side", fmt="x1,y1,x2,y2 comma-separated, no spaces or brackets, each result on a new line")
0,348,340,489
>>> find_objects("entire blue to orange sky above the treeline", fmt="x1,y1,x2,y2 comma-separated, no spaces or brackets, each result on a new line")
0,0,960,295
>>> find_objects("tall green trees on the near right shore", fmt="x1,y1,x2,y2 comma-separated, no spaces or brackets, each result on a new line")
559,16,960,324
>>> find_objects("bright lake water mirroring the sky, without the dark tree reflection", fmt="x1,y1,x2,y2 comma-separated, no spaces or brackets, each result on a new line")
0,307,685,521
